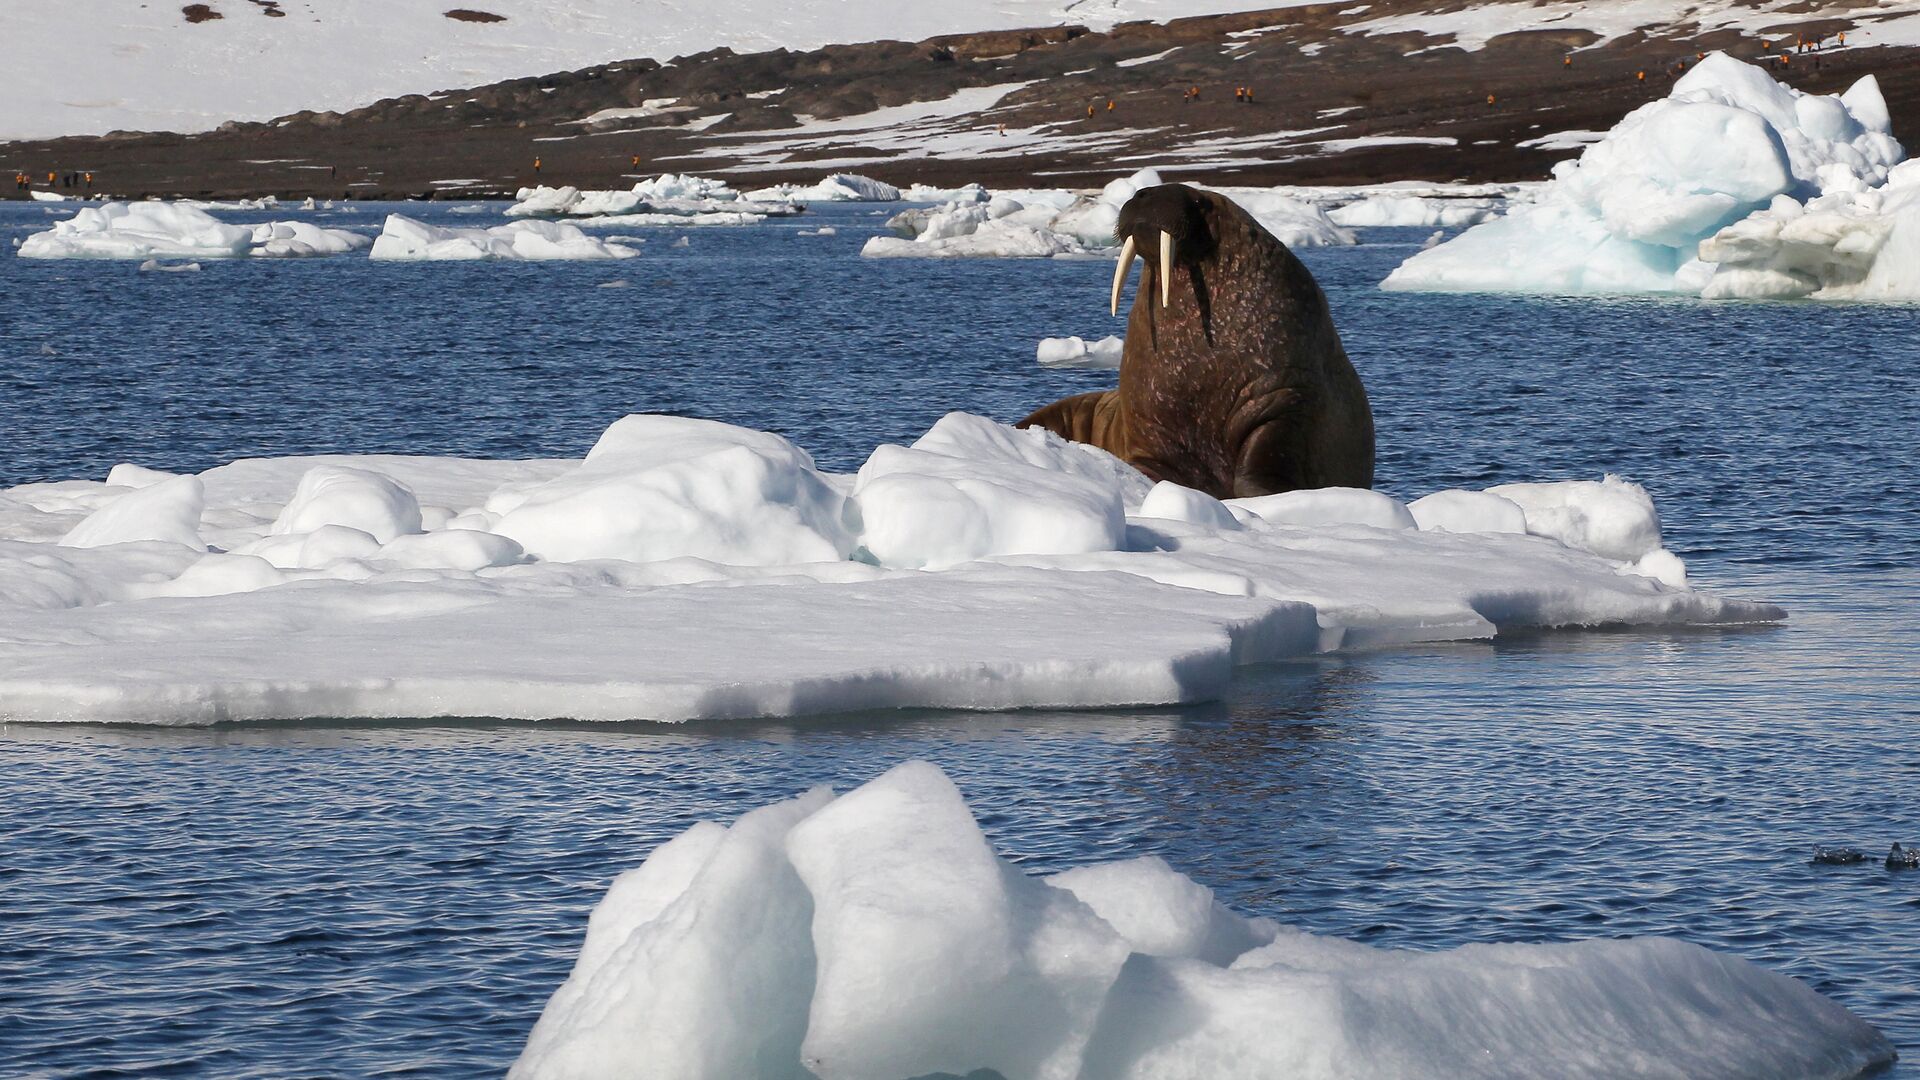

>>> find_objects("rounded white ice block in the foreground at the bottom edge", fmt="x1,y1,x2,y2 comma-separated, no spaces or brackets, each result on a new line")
509,761,1893,1080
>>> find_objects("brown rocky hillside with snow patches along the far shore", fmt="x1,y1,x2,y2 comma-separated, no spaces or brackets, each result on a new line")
0,0,1920,198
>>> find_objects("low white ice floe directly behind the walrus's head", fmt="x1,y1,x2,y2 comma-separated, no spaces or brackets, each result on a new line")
860,169,1356,259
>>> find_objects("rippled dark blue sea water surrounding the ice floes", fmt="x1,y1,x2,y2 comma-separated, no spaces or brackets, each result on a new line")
0,206,1920,1076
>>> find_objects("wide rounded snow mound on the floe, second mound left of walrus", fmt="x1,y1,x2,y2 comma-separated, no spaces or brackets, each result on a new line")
488,415,854,567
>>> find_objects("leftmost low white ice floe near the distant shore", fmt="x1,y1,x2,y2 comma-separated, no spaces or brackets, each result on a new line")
19,202,372,259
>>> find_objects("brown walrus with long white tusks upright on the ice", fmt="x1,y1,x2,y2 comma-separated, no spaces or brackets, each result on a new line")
1018,184,1373,498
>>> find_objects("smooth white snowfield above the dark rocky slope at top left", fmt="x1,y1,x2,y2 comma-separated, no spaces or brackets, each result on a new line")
0,0,1284,140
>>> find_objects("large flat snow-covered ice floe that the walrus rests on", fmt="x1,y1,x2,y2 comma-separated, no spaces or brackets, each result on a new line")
0,413,1784,724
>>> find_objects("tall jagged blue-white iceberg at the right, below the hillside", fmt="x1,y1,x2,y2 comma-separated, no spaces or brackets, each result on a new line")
1382,54,1920,302
